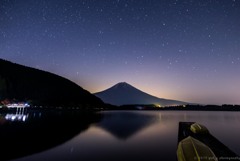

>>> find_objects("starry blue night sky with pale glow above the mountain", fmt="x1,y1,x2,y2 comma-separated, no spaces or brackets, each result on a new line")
0,0,240,104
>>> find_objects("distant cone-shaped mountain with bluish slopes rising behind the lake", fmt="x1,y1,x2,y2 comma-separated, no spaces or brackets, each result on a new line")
95,82,188,106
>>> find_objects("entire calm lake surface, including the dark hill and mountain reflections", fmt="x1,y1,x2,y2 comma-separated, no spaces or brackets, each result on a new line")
0,111,240,161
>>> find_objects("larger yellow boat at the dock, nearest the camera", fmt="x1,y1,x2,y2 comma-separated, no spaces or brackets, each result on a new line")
177,136,218,161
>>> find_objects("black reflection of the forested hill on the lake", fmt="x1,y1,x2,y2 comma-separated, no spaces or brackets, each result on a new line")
0,111,101,160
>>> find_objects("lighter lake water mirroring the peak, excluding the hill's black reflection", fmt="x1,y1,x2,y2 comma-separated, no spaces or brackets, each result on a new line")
6,111,240,161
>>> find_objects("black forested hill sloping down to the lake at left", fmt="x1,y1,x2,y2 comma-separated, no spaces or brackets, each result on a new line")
0,59,103,107
